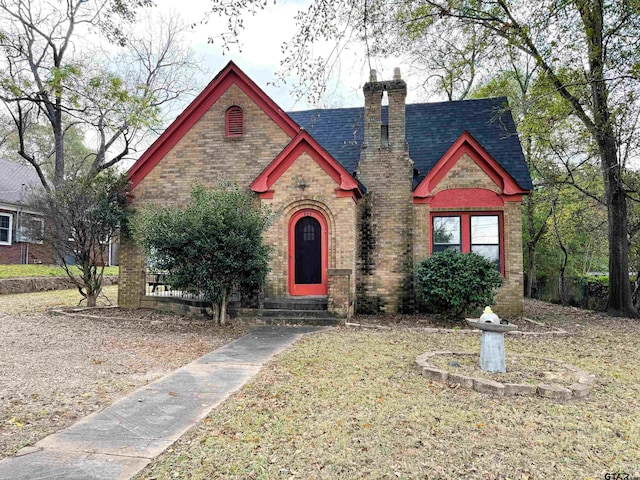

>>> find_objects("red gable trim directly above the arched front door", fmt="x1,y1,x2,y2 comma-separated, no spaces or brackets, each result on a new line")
251,130,362,197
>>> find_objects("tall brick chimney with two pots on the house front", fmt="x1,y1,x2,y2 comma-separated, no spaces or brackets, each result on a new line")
356,69,413,312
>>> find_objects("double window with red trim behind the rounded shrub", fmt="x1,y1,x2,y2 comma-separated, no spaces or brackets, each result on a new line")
431,212,504,273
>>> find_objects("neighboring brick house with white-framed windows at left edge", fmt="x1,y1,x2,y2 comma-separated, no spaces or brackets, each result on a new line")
0,159,54,264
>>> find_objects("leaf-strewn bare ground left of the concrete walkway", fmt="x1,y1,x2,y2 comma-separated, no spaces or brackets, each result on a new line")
0,292,246,458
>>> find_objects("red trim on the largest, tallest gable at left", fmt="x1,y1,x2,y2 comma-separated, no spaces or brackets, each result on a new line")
129,62,300,188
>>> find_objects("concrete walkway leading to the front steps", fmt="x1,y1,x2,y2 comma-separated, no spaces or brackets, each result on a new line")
0,327,323,480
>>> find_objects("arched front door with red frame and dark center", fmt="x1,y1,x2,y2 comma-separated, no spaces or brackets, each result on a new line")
289,209,328,295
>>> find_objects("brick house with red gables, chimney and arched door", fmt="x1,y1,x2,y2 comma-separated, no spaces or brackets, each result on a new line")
119,62,532,316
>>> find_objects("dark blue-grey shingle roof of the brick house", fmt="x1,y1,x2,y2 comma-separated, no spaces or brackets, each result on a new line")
289,97,532,190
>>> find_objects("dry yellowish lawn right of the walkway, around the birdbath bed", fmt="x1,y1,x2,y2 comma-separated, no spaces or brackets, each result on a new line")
137,303,640,480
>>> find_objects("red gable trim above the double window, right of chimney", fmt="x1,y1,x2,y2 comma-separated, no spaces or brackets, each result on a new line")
413,131,528,199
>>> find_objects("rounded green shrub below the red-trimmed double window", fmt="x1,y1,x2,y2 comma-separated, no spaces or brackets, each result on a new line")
415,250,502,317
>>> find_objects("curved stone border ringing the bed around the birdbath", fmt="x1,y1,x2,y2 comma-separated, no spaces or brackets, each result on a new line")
415,351,596,400
